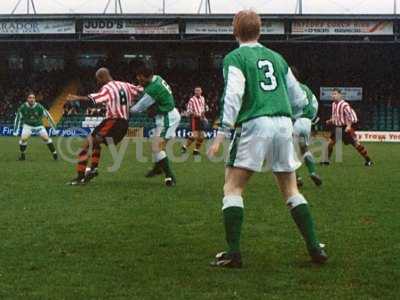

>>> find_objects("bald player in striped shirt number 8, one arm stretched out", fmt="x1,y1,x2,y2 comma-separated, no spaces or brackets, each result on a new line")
67,68,140,185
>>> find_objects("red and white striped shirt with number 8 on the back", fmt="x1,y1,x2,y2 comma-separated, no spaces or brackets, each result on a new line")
89,81,141,120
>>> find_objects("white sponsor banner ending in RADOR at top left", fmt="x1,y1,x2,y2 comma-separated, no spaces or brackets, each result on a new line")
0,20,75,34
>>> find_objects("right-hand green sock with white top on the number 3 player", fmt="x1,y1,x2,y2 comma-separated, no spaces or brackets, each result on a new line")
287,194,319,252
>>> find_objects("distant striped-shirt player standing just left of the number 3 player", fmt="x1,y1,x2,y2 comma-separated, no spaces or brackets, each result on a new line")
181,86,207,155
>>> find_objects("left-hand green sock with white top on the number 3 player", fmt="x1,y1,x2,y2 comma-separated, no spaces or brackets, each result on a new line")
222,196,243,253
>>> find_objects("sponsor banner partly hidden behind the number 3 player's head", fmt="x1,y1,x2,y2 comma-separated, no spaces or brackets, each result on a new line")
186,21,285,34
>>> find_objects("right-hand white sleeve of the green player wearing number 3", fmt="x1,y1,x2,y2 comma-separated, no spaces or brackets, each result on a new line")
285,68,308,119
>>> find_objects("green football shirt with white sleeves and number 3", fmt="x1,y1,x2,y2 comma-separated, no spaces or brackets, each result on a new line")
220,43,307,127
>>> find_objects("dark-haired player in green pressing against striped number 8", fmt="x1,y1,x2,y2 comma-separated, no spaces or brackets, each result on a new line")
131,63,181,186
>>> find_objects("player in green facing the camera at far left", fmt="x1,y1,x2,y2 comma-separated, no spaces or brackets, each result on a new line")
14,93,58,160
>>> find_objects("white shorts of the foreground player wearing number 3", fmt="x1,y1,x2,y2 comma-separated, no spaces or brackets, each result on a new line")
227,117,301,172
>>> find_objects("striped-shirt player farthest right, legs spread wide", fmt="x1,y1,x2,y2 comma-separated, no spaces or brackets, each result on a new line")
321,89,373,167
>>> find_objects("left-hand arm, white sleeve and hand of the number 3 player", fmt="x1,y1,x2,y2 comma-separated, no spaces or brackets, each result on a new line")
208,57,246,156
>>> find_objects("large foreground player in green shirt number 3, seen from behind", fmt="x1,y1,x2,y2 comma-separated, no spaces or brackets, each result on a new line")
208,10,327,268
